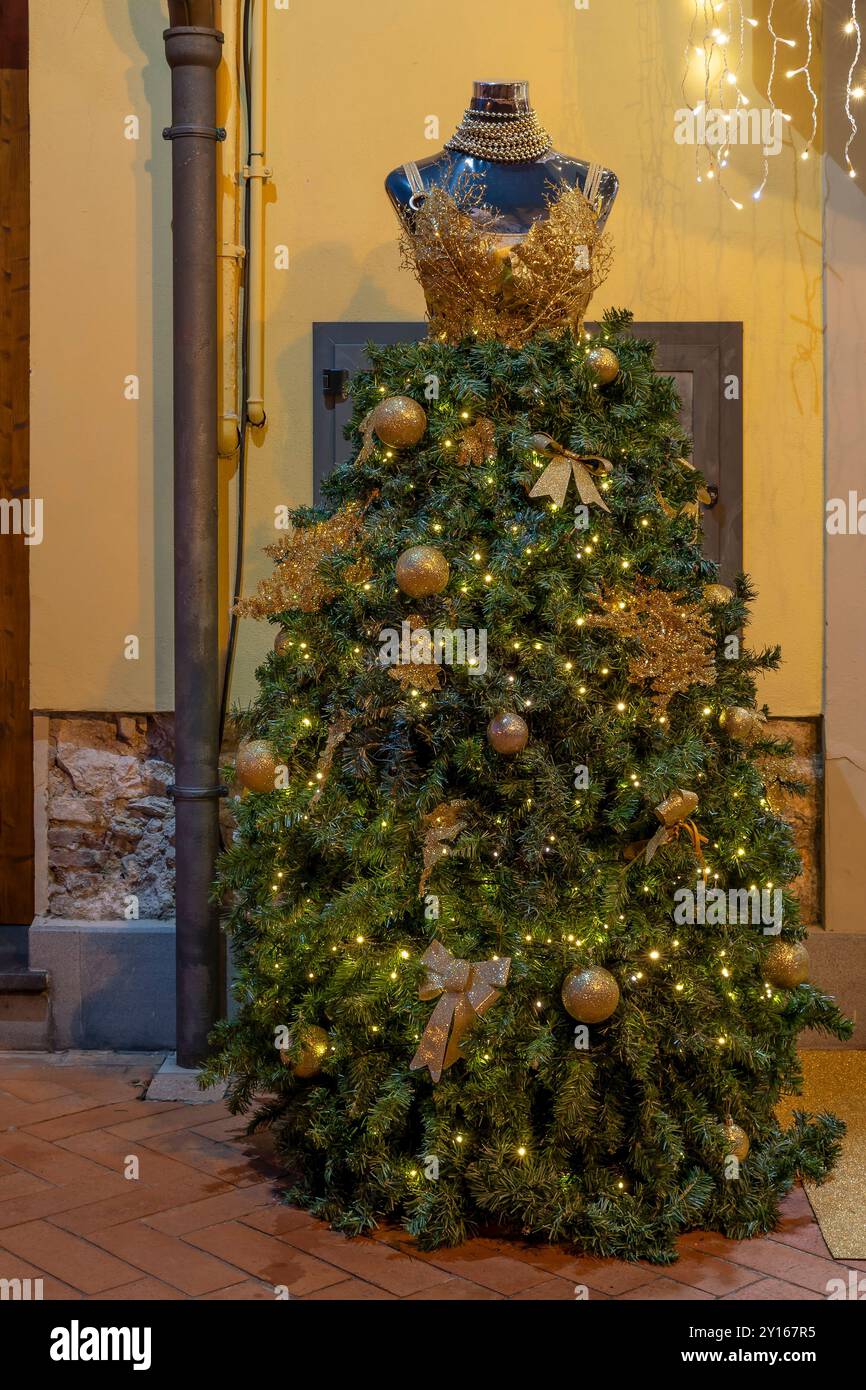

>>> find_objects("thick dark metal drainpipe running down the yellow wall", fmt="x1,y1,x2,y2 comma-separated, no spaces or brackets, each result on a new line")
163,8,225,1068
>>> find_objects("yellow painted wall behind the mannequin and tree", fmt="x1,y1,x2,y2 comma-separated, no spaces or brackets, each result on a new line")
32,0,823,714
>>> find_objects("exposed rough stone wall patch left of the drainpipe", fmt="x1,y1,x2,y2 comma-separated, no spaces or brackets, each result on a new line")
47,714,174,922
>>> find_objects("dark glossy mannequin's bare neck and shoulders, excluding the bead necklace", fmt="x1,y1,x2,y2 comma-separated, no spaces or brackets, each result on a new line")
385,82,619,245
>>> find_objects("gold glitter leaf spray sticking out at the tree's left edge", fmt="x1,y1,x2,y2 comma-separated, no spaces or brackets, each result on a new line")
235,502,373,617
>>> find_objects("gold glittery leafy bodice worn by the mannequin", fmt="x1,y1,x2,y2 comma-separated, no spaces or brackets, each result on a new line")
400,181,610,348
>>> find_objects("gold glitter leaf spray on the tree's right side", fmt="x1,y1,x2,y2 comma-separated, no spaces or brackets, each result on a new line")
587,580,716,714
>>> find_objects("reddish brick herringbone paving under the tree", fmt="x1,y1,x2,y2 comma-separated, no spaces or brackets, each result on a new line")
0,1054,866,1301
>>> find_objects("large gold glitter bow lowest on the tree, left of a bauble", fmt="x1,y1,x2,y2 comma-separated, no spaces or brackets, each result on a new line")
409,941,512,1081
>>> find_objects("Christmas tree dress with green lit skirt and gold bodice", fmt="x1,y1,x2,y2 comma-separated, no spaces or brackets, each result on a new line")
207,100,847,1261
